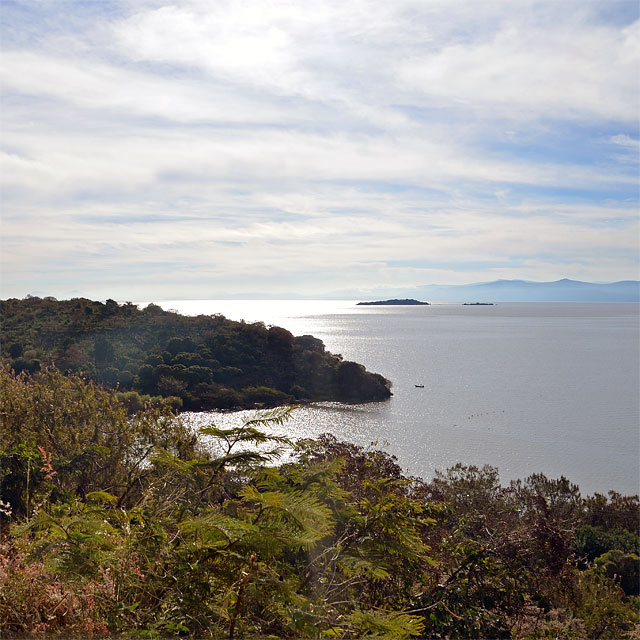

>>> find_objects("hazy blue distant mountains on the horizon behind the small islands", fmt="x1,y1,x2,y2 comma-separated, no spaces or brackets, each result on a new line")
356,278,640,302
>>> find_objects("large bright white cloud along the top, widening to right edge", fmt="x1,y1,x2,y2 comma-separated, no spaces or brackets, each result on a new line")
110,2,640,121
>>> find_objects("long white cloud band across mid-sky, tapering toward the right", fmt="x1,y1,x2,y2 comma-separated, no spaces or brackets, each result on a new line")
0,117,635,198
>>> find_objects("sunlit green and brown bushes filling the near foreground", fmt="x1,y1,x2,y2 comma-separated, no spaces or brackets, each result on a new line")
0,368,638,639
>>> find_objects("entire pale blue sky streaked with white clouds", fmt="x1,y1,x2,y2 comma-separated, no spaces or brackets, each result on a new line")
0,0,640,301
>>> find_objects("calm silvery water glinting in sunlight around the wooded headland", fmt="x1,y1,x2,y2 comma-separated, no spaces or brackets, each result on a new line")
152,300,640,494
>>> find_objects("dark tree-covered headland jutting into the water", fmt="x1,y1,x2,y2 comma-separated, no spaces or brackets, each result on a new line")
0,297,391,410
